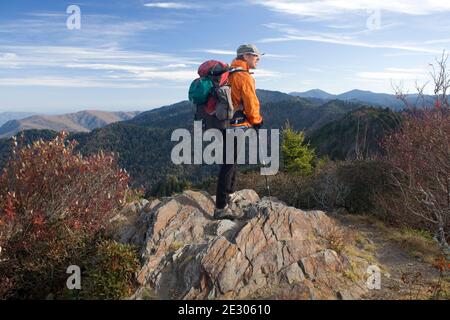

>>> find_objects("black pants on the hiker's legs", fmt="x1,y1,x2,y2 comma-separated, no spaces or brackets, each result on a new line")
216,130,238,209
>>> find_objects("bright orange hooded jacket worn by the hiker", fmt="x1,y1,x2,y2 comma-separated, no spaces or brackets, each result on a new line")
229,59,262,127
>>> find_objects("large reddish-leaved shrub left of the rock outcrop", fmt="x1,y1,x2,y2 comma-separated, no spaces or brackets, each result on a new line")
0,132,129,298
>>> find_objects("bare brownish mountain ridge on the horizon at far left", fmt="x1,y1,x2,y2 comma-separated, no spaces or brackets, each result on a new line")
0,110,139,138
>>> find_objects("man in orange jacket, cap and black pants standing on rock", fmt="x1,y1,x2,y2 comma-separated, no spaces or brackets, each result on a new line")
214,44,263,219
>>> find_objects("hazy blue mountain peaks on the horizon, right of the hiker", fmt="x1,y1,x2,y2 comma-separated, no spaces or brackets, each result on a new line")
290,89,434,110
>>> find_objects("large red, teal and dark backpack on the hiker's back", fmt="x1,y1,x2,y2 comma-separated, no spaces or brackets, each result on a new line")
189,60,247,130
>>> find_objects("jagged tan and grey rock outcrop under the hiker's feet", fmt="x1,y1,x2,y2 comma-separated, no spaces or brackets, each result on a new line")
108,189,369,299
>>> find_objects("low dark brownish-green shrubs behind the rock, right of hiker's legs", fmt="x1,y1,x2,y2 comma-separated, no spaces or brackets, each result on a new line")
238,160,390,214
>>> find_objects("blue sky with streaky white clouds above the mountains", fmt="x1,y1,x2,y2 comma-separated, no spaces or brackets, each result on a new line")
0,0,450,113
